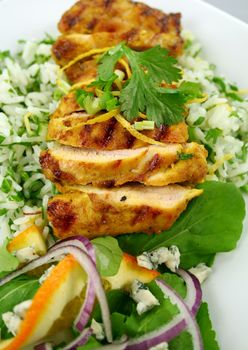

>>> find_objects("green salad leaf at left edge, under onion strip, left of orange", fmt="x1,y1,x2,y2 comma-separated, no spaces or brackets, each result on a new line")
0,276,40,339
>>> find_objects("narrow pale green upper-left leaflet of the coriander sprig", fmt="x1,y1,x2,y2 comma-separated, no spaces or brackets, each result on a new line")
97,43,123,81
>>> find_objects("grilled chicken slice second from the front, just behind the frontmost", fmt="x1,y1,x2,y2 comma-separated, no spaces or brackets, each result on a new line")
40,143,207,187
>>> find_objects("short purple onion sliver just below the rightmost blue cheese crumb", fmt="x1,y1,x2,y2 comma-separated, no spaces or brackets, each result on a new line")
177,269,202,316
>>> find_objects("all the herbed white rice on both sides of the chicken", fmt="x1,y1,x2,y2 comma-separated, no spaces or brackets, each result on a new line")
0,32,248,244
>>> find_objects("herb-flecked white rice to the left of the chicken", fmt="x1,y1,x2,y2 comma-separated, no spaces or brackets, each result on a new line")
0,36,62,244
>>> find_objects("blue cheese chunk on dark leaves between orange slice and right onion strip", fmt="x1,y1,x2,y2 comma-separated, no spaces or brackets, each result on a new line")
131,280,159,315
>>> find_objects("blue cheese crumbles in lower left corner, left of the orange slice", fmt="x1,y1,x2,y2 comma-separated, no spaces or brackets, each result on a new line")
2,300,32,336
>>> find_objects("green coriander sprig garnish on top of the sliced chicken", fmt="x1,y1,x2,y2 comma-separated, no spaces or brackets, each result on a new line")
74,43,201,126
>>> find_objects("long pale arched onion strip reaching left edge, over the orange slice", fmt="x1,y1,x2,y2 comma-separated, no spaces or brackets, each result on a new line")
0,245,112,342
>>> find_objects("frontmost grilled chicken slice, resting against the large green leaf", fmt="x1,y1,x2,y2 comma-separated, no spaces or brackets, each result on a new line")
48,185,202,238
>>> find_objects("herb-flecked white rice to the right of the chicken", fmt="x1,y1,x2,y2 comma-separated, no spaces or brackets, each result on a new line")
179,32,248,192
